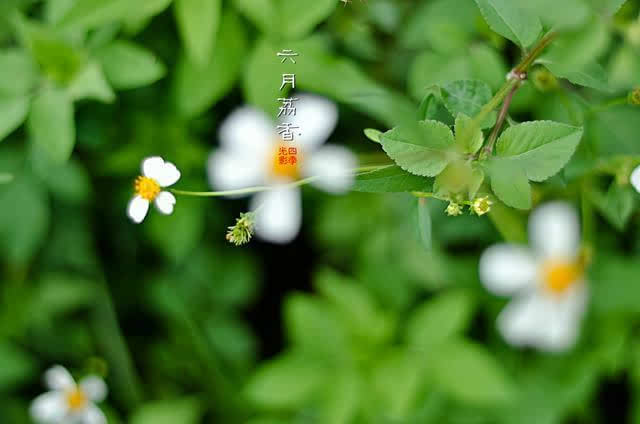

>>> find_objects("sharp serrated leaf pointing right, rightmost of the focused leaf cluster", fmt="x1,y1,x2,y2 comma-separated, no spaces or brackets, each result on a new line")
496,121,583,181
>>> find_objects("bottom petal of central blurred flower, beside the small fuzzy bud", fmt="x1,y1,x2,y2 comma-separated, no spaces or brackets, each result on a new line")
251,187,302,244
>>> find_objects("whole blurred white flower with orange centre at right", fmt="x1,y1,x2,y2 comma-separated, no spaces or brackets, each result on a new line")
480,202,588,351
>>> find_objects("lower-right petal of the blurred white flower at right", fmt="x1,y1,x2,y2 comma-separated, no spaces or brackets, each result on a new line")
538,283,588,352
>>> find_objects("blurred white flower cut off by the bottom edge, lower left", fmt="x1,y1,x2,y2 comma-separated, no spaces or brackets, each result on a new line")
30,365,107,424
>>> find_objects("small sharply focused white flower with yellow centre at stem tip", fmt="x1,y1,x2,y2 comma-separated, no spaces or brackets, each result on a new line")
127,156,180,224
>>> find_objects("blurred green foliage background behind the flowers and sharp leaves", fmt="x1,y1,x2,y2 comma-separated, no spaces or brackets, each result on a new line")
0,0,640,424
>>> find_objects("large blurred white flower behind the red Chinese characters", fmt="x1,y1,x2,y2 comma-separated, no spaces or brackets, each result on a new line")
208,94,356,243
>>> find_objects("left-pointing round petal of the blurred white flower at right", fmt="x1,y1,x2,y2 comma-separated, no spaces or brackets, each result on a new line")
479,244,536,295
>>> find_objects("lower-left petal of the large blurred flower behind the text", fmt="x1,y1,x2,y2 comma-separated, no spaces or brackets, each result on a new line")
207,149,268,190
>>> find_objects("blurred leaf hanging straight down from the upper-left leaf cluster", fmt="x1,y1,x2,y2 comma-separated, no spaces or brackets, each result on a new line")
28,87,76,163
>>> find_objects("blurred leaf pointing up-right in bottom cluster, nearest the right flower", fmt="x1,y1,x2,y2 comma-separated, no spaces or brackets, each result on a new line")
405,291,473,352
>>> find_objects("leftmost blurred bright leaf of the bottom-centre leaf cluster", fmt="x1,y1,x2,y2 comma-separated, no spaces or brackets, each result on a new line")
245,352,327,409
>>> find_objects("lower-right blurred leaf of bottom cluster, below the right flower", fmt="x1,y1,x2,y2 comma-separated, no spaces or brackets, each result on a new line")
429,341,515,406
